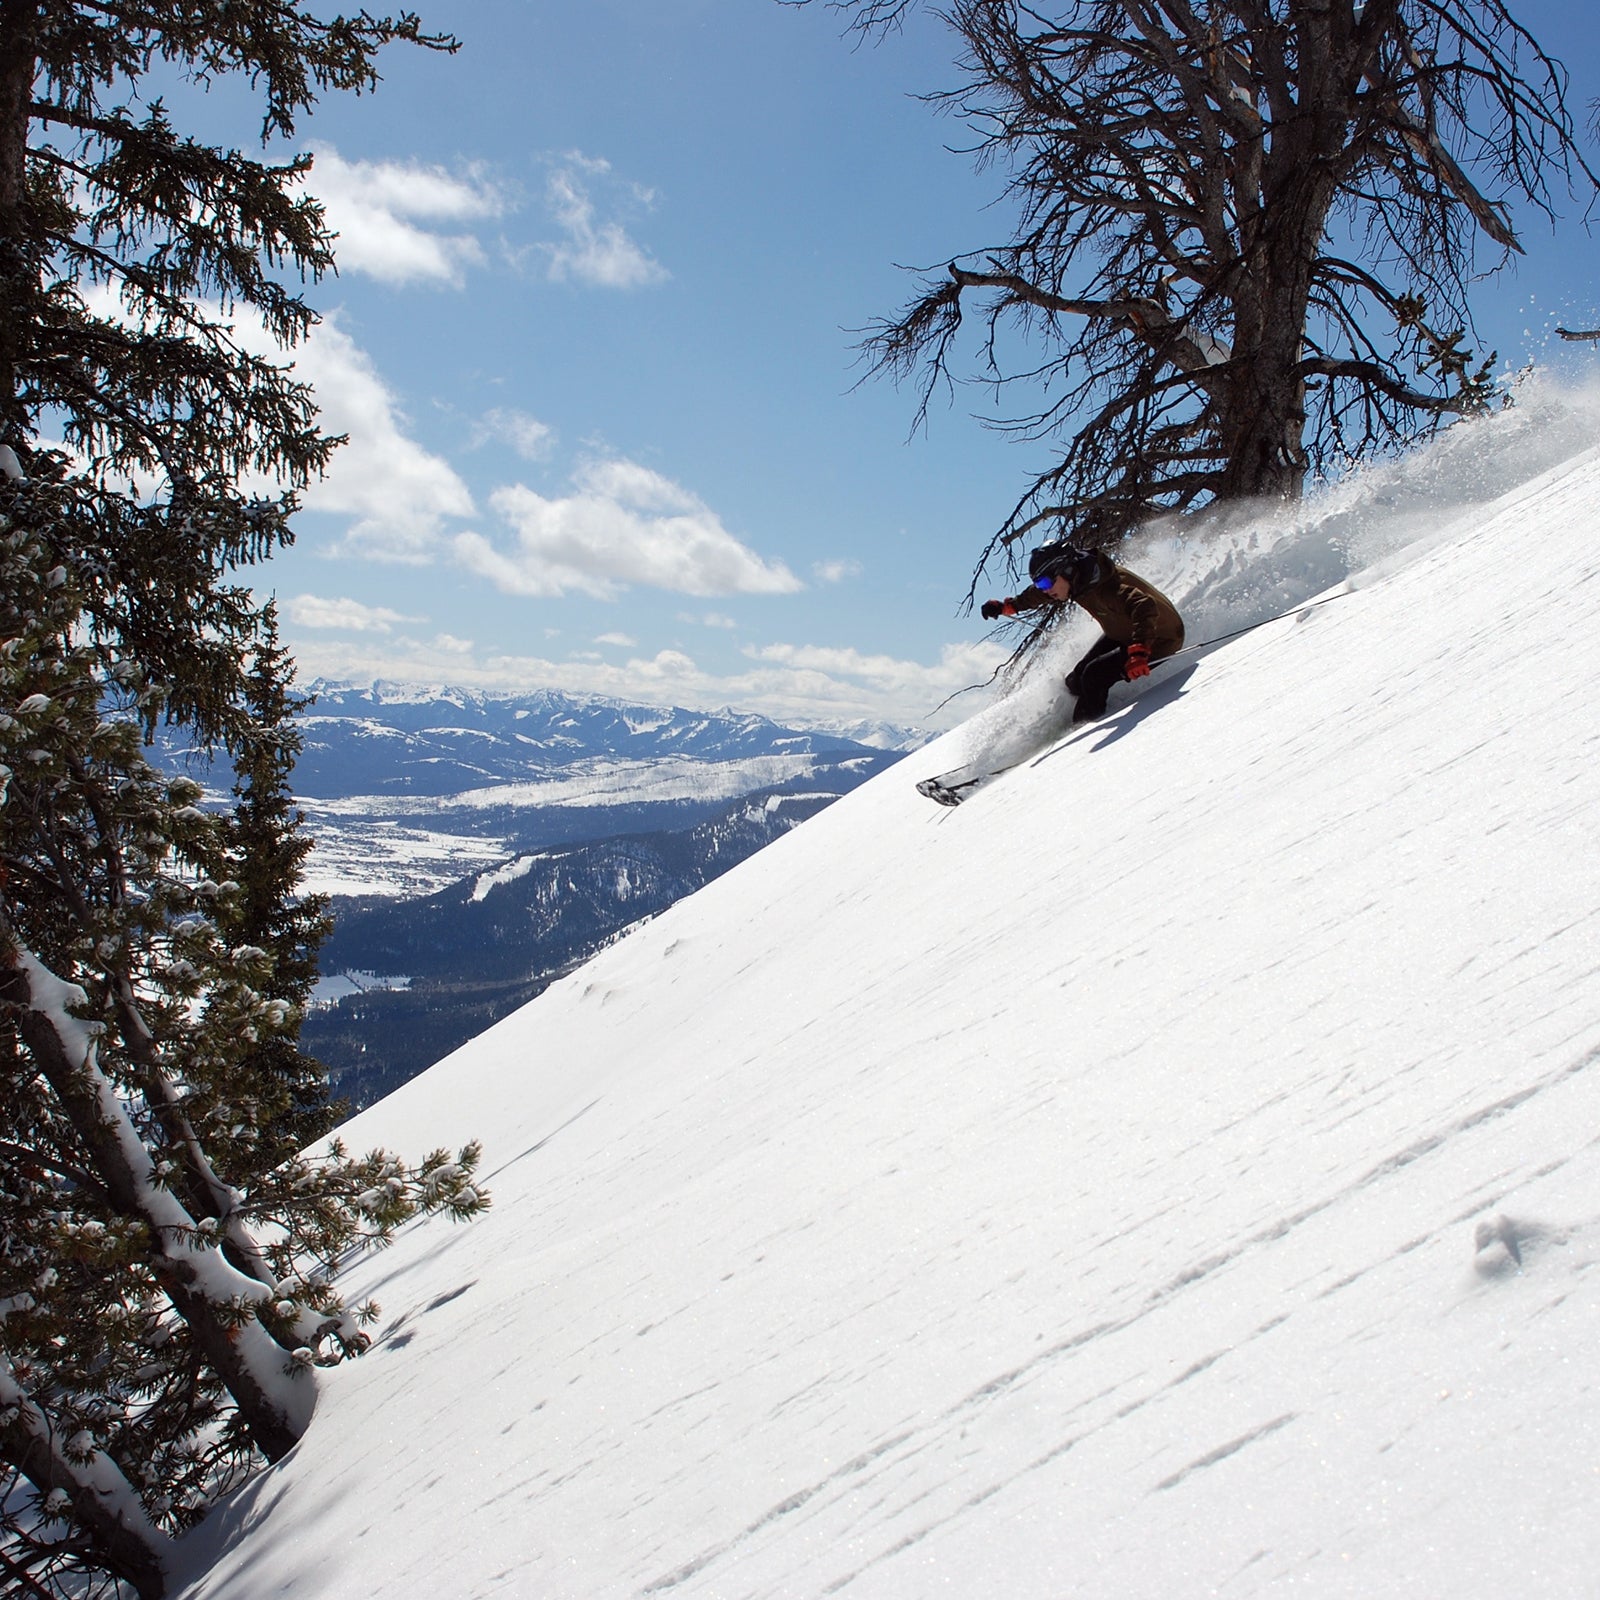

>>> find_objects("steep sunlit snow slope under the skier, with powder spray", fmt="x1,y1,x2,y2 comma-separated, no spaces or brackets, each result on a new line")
172,387,1600,1600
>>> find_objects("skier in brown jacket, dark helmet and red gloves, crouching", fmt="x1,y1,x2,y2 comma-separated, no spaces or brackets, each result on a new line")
982,539,1184,723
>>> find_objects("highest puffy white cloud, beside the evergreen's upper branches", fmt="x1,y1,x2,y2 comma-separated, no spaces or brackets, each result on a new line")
304,146,506,288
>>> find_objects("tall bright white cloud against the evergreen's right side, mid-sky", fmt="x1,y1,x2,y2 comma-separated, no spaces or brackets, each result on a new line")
294,318,474,562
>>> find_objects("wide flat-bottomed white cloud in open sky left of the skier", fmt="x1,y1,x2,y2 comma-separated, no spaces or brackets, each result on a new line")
454,461,803,598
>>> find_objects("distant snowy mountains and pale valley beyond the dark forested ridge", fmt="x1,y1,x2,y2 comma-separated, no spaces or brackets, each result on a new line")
158,680,926,899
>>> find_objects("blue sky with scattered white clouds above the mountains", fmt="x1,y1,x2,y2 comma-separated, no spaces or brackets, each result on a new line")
190,0,1600,722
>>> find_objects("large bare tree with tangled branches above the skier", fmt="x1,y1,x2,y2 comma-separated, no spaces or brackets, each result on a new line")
806,0,1595,595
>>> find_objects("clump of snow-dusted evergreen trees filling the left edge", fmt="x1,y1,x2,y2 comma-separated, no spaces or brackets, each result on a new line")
0,0,486,1597
